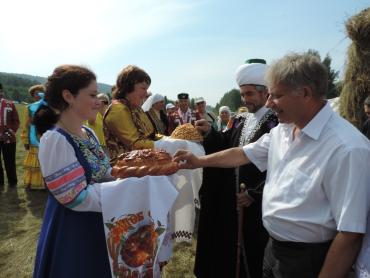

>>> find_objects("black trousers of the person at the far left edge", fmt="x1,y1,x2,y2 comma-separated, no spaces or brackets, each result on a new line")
0,141,17,185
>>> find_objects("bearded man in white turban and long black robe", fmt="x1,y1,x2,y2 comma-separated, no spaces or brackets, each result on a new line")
194,59,278,278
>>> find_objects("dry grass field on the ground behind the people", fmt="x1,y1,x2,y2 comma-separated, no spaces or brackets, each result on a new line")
0,105,195,278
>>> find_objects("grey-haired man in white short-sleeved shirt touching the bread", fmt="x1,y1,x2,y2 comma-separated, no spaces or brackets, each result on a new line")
175,54,370,278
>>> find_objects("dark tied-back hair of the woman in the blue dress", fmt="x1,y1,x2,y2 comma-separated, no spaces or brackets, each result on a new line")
33,65,96,135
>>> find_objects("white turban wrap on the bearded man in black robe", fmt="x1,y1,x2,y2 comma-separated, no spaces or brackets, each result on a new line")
236,63,267,87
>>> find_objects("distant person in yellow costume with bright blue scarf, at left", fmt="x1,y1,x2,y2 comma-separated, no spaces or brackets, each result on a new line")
21,85,45,189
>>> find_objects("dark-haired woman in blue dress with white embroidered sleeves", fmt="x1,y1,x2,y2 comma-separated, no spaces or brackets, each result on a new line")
33,65,111,278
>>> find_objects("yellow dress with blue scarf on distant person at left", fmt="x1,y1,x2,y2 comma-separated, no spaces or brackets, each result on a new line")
21,104,45,190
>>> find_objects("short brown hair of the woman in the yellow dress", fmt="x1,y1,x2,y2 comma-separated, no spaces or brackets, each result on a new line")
112,65,152,99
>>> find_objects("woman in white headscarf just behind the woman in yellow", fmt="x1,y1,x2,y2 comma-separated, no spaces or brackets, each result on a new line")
142,94,168,135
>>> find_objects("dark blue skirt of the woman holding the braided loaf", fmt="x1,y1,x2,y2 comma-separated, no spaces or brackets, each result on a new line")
33,195,112,278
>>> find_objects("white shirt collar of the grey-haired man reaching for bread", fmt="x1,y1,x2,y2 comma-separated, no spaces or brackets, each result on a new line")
301,102,334,140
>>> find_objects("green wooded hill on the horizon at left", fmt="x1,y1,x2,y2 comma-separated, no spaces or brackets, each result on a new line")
0,72,112,103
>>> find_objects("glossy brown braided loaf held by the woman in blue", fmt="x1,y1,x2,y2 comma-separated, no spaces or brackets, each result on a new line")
111,149,179,178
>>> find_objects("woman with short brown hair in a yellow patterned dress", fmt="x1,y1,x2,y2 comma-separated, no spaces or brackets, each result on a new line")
103,65,158,163
